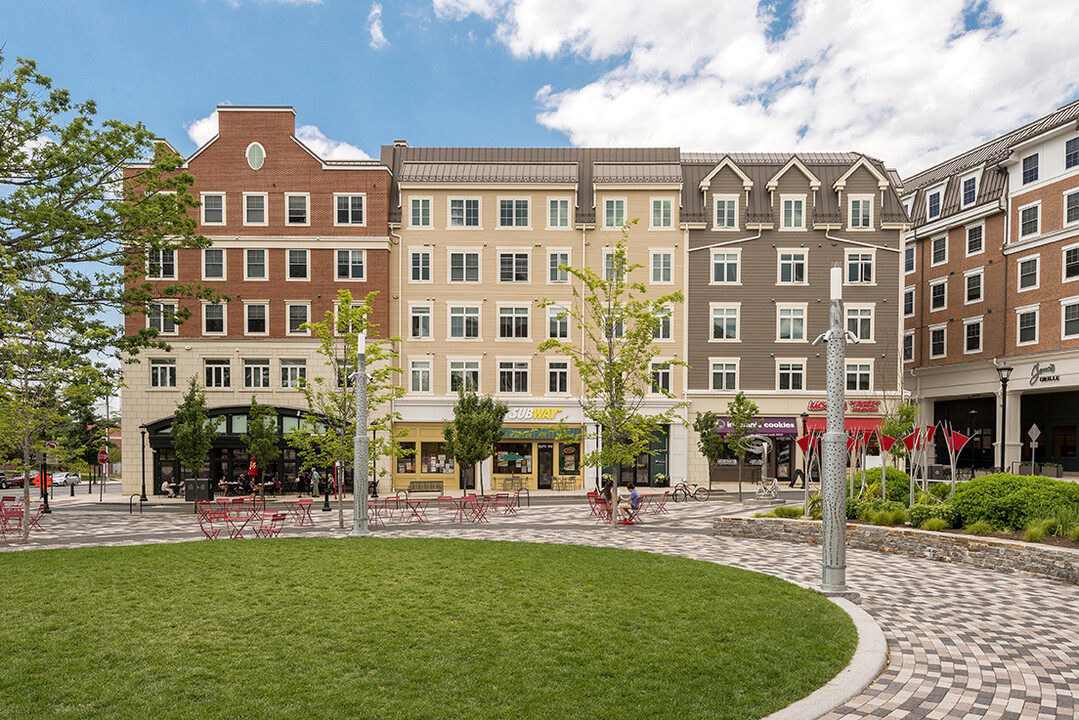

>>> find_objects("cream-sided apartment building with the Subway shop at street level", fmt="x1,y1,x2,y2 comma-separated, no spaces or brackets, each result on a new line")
382,141,687,496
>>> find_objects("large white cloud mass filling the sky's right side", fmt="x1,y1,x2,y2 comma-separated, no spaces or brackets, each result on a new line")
434,0,1079,174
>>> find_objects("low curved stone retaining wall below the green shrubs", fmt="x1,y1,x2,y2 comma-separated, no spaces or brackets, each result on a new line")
713,517,1079,585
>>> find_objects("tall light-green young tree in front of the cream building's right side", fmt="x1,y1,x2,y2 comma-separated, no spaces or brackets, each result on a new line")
538,219,686,524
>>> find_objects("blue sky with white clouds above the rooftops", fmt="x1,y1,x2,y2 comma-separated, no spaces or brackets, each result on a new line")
0,0,1079,177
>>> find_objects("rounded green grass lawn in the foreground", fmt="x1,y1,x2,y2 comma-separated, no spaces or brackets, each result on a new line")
0,539,856,720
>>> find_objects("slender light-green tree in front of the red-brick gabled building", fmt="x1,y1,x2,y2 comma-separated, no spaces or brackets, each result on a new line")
288,290,407,527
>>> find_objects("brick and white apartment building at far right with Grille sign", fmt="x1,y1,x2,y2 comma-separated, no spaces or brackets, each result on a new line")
903,103,1079,471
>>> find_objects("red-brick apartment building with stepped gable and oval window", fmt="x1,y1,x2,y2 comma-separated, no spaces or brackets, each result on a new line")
123,106,391,492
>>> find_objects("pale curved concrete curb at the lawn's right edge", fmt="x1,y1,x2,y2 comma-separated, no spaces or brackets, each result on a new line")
762,597,888,720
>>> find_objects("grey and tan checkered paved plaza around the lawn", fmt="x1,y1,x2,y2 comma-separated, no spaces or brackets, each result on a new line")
0,501,1079,720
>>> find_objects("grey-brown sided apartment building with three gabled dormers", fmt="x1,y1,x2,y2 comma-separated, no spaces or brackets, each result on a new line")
682,153,906,479
